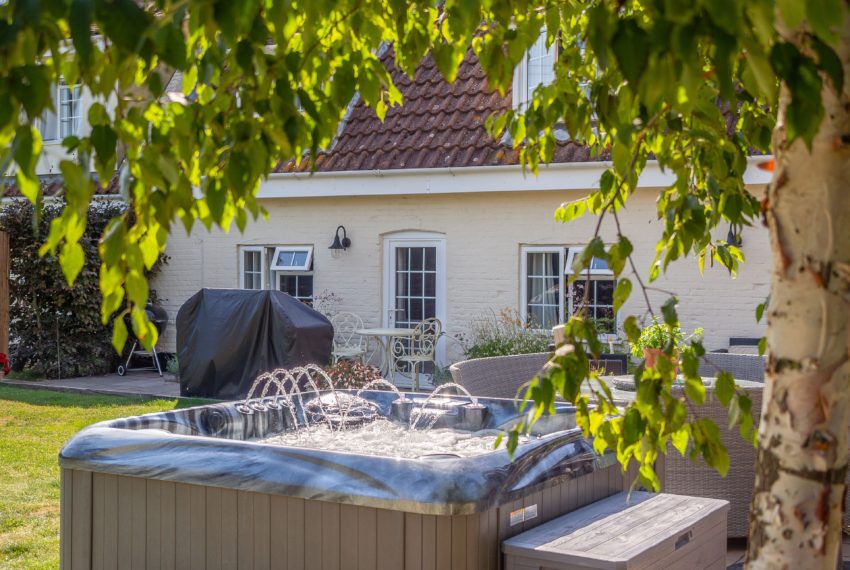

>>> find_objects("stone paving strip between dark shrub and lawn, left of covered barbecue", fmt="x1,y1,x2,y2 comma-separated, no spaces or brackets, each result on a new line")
2,372,180,398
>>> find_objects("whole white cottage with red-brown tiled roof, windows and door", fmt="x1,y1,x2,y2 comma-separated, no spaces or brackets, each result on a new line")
153,46,770,364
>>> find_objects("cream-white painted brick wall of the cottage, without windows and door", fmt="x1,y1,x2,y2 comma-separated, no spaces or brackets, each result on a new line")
154,189,770,359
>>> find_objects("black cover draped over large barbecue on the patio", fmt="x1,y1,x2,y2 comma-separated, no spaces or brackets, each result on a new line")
177,289,333,394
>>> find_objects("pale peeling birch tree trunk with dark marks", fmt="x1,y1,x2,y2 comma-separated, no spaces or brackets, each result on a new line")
747,13,850,570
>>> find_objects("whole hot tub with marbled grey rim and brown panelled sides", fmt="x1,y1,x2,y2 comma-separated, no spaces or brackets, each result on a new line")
59,391,624,570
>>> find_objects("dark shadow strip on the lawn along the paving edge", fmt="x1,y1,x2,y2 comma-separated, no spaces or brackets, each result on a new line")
0,384,209,410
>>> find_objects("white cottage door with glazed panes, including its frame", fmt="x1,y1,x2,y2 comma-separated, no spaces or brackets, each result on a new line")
383,233,446,362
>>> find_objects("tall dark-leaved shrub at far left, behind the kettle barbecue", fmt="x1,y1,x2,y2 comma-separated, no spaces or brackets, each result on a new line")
0,200,167,378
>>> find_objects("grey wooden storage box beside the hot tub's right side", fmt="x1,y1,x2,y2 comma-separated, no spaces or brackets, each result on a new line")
502,492,729,570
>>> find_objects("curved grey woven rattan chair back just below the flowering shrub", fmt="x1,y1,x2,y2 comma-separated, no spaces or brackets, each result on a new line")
449,352,551,398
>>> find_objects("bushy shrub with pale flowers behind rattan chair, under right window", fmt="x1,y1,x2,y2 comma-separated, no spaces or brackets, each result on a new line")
460,309,552,358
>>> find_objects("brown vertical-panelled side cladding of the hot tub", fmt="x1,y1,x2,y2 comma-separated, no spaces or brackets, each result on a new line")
61,465,625,570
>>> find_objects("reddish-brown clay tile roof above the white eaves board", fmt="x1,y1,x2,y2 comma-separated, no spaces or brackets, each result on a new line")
277,50,592,172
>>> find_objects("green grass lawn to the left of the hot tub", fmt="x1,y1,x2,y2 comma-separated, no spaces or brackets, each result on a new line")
0,385,205,570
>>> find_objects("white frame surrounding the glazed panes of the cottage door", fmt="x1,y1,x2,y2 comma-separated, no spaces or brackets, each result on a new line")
381,232,448,365
